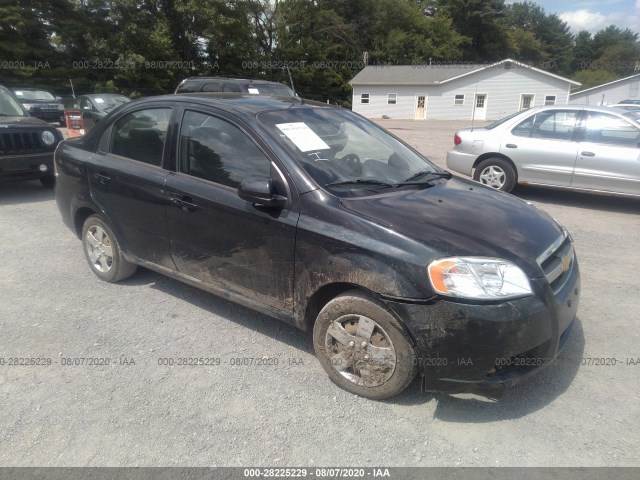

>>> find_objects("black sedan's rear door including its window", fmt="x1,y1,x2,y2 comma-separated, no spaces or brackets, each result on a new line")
88,105,175,269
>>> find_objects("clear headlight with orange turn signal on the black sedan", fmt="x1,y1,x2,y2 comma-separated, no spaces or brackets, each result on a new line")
428,257,533,300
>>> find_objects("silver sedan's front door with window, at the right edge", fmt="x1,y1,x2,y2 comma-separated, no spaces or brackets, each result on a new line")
571,112,640,195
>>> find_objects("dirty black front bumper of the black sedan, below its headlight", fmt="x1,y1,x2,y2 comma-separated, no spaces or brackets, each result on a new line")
385,261,580,398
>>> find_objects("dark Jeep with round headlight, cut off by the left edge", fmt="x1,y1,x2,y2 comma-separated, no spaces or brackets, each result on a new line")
0,85,62,188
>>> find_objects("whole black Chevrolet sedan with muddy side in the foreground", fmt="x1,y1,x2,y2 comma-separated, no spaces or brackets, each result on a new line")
55,94,580,398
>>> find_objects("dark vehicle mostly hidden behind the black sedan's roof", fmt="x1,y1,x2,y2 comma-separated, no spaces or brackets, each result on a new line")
175,77,296,97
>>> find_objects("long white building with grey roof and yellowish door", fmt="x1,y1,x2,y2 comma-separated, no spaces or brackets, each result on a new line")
351,59,580,120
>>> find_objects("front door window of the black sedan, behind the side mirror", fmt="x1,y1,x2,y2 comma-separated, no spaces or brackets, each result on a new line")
179,111,271,188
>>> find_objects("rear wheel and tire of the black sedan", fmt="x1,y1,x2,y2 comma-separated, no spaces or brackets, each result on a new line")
82,215,138,283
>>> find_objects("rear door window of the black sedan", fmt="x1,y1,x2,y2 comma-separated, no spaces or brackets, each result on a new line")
110,108,171,166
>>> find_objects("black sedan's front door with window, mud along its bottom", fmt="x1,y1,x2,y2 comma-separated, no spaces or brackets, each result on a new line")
166,110,299,313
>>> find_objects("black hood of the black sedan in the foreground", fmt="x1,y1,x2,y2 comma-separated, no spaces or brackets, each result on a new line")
341,178,562,276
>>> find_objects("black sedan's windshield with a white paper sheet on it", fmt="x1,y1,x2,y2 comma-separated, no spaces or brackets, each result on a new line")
258,108,442,197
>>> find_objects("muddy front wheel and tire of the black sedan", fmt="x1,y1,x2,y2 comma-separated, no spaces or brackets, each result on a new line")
313,290,418,400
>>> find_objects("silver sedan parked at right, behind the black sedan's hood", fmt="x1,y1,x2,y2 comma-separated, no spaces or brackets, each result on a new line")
447,105,640,196
